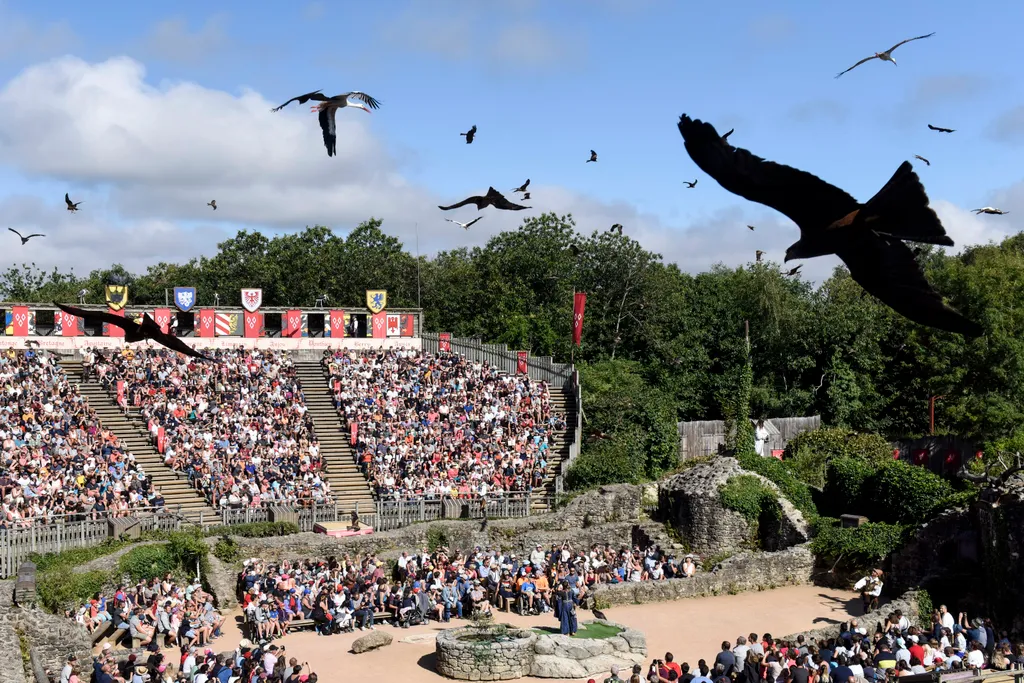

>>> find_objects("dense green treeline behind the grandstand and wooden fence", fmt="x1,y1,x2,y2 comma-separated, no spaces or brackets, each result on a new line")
8,214,1024,478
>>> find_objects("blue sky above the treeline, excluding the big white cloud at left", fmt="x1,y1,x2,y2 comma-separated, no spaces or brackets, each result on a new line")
0,0,1024,273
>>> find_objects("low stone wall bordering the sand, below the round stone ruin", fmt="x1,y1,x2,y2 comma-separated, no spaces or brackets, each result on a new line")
593,546,814,606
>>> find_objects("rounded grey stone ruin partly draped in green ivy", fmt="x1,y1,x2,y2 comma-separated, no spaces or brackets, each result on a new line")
658,457,810,555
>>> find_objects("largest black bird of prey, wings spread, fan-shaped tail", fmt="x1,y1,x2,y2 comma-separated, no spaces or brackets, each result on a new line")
679,115,983,337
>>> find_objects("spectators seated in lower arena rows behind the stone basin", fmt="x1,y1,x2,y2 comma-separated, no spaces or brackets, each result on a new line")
238,543,696,640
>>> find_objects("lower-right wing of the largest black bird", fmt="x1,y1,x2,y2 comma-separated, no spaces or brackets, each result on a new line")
837,232,984,337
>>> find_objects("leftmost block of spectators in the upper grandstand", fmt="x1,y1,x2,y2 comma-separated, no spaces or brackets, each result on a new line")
0,349,164,528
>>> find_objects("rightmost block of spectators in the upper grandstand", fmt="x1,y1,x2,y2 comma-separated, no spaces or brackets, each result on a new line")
323,349,565,500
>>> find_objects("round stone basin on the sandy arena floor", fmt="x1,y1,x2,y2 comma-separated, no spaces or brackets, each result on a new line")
436,624,537,681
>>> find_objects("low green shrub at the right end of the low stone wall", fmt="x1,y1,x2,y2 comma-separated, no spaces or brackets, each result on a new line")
811,517,913,569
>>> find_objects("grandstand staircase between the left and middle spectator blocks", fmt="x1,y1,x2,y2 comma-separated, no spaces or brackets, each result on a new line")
60,358,218,523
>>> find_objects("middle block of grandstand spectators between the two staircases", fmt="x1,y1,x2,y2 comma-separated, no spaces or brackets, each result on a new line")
85,346,331,508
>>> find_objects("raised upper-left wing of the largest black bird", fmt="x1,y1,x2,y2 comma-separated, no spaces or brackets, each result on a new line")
679,114,859,231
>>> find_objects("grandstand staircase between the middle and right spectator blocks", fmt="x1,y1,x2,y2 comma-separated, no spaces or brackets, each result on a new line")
295,360,375,515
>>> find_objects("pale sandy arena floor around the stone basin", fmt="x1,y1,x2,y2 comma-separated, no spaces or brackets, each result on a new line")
190,586,860,682
